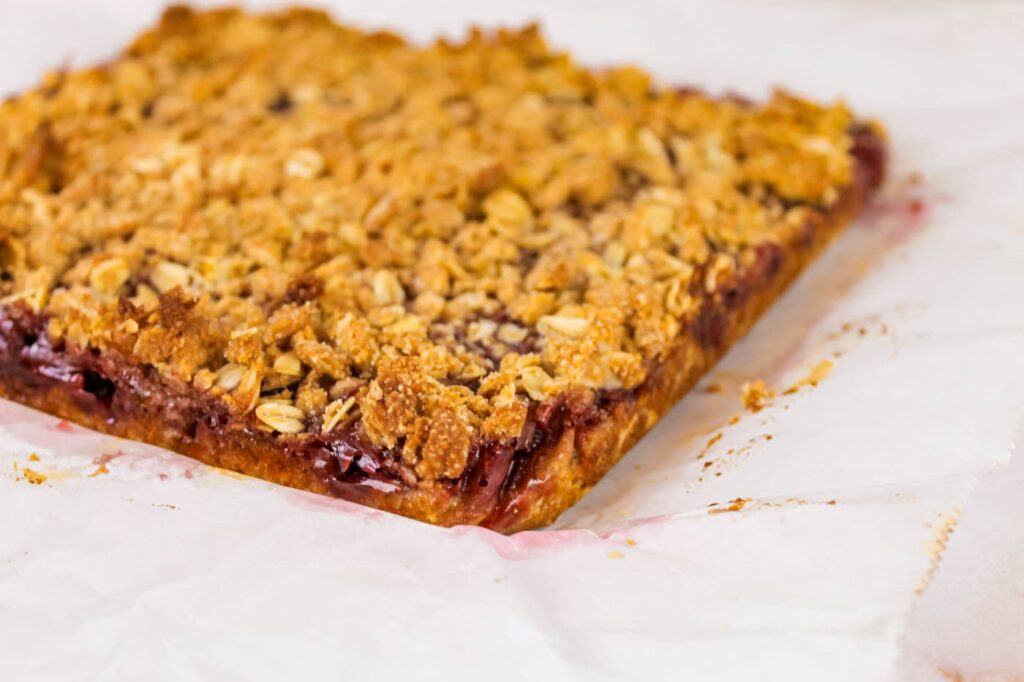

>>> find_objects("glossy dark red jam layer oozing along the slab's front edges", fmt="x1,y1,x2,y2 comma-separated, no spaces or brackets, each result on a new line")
0,306,618,514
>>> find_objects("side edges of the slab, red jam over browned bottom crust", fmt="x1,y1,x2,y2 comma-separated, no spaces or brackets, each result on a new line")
0,127,885,532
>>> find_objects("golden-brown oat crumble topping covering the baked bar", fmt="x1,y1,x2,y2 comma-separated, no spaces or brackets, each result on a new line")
0,7,876,480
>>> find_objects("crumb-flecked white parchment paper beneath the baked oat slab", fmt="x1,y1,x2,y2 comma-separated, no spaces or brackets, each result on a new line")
0,0,1024,681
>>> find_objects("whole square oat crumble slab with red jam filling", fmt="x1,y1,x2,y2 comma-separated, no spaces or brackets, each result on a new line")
0,8,885,531
